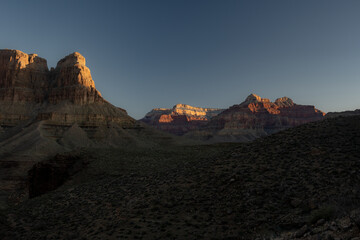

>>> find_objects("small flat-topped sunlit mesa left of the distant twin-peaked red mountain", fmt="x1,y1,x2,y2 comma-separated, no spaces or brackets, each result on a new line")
141,104,223,135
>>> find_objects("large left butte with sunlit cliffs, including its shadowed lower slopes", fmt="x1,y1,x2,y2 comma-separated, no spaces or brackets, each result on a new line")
0,50,175,208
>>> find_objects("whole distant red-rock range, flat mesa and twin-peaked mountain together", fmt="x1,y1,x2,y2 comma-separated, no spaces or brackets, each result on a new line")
141,94,325,142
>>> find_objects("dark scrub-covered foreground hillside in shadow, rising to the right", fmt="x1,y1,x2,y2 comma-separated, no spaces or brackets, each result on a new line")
0,116,360,240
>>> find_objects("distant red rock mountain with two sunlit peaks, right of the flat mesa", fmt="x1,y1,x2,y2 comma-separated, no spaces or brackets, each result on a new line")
186,94,325,142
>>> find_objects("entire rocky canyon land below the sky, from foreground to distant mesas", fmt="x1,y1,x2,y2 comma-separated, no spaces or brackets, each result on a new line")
0,50,360,240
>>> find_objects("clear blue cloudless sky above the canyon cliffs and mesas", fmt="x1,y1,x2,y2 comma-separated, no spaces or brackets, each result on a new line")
0,0,360,119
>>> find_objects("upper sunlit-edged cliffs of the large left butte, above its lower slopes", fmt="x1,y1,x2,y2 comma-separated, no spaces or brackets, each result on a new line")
0,50,135,128
